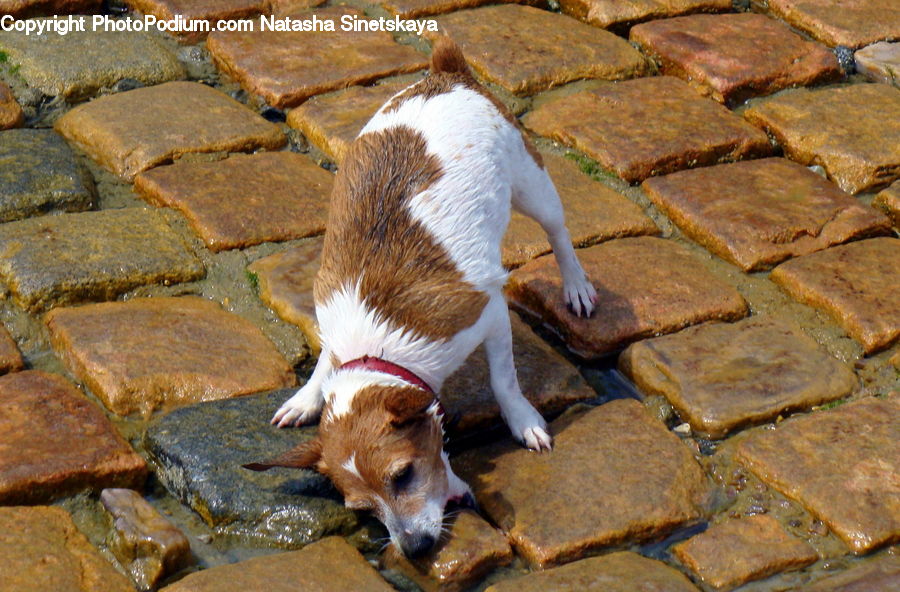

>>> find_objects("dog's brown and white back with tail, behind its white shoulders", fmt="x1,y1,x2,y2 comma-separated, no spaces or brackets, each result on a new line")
316,42,533,356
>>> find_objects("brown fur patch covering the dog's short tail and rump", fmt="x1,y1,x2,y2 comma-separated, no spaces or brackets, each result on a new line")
383,36,544,168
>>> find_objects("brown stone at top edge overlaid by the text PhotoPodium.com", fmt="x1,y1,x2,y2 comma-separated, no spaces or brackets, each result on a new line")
126,0,270,43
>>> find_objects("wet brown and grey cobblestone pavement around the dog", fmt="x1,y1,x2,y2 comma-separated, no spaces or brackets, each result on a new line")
0,0,900,592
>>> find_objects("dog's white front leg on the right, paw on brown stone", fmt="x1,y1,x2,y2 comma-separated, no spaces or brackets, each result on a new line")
484,294,553,451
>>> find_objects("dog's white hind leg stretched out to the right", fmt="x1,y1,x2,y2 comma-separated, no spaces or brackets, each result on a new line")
512,155,597,317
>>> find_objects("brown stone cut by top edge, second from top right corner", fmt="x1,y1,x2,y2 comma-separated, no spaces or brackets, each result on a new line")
559,0,731,30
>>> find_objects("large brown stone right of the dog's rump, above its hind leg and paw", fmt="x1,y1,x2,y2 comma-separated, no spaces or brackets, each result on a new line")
523,76,772,183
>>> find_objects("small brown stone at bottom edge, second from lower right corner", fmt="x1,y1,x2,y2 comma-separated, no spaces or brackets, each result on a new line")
672,515,819,590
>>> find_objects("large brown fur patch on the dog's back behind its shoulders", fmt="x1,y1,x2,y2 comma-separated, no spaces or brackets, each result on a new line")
314,126,488,340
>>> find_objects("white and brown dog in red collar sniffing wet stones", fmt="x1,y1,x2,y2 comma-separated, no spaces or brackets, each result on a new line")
248,39,596,557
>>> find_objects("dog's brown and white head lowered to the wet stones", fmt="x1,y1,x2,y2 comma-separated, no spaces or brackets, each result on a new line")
246,385,459,557
